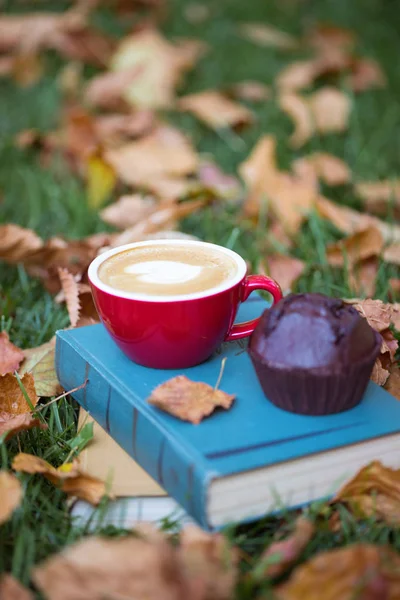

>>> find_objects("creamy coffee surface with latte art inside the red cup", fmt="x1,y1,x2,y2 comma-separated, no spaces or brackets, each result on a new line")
98,244,238,296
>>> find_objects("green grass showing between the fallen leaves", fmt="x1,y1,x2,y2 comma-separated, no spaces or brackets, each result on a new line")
0,0,400,599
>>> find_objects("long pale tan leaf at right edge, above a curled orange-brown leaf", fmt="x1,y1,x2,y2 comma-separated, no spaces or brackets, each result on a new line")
316,196,400,245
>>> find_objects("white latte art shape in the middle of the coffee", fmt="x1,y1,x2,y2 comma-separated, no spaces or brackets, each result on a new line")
124,260,203,285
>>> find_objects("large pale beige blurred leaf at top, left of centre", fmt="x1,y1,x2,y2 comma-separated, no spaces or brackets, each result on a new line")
111,28,205,109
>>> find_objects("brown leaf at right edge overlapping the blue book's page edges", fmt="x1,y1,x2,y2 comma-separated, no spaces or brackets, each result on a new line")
331,460,400,525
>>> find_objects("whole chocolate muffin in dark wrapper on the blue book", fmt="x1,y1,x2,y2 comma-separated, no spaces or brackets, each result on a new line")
248,293,382,415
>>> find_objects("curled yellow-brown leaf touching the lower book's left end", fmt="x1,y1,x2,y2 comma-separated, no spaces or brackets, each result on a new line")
12,452,109,505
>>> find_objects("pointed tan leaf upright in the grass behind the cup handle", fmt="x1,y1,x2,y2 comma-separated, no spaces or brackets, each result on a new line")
239,136,316,234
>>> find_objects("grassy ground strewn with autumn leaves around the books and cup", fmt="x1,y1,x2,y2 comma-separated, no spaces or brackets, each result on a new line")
0,0,400,600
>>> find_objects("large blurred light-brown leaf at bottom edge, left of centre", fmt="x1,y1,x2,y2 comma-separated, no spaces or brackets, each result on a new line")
33,530,191,600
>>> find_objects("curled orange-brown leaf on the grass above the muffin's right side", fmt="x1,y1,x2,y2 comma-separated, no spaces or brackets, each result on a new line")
326,225,384,267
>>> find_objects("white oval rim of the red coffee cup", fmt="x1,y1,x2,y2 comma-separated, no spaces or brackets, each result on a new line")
88,239,247,303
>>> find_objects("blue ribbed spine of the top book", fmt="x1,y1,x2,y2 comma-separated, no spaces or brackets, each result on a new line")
55,336,216,529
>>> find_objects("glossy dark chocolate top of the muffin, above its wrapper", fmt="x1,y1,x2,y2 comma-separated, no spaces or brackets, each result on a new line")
249,293,377,370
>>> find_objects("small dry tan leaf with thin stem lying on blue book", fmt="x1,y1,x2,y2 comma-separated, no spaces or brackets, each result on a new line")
147,375,235,424
